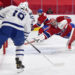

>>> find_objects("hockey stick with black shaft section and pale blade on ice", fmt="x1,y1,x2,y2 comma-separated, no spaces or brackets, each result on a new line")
26,40,64,66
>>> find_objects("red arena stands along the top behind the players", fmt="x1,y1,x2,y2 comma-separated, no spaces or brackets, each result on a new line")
0,0,75,14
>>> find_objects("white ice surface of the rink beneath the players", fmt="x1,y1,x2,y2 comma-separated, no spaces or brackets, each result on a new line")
0,31,75,75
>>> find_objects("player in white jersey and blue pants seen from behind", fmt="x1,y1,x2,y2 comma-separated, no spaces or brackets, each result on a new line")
0,1,31,72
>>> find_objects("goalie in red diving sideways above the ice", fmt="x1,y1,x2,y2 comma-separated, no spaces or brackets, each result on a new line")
34,9,75,49
